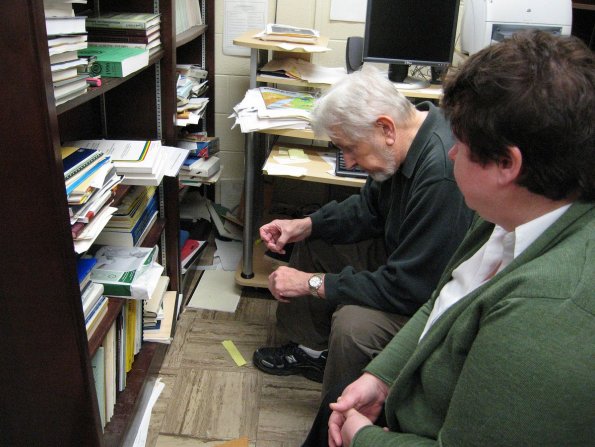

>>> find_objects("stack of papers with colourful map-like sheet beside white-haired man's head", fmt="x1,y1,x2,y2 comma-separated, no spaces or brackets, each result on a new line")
229,87,316,133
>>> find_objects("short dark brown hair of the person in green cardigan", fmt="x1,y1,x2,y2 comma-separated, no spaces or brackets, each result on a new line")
442,31,595,201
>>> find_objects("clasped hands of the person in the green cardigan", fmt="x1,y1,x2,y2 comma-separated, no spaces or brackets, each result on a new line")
328,373,388,447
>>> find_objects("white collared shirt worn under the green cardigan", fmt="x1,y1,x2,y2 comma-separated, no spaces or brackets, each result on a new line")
419,204,570,341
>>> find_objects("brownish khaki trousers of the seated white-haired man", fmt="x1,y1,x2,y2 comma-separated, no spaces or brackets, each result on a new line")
277,239,408,396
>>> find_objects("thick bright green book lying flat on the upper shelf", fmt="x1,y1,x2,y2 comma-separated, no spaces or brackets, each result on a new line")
78,46,149,78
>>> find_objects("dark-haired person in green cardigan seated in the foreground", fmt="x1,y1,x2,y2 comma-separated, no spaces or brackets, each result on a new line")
304,31,595,447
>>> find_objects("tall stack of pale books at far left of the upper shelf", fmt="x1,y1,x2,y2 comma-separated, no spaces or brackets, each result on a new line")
44,0,87,105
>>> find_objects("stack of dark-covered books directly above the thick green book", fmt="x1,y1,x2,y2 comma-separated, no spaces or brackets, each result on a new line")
86,12,161,61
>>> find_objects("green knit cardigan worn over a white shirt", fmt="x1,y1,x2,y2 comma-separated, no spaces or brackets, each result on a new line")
352,203,595,447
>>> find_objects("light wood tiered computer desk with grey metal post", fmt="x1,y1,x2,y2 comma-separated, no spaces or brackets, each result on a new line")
233,30,442,287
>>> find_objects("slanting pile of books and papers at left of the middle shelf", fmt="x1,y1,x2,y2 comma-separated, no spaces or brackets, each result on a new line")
61,146,122,253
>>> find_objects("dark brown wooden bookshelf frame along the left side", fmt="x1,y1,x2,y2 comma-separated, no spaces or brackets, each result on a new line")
0,0,214,447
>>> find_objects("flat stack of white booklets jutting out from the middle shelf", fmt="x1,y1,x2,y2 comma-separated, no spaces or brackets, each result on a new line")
66,140,166,186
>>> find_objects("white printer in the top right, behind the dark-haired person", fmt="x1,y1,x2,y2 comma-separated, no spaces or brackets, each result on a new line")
461,0,572,54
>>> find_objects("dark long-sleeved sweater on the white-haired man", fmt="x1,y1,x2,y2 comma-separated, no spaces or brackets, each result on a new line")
310,102,472,315
